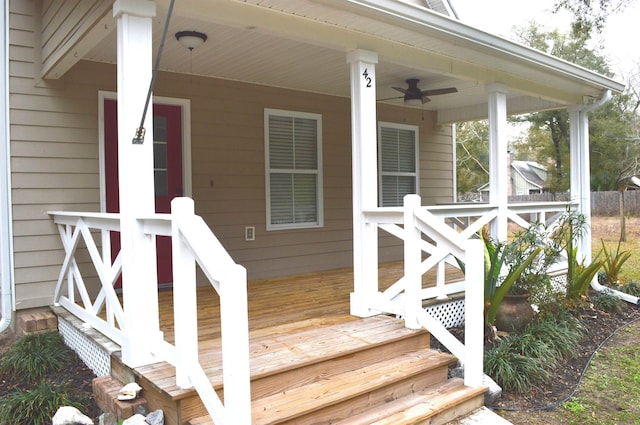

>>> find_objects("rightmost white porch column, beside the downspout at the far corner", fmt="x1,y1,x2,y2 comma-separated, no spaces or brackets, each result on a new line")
568,106,591,263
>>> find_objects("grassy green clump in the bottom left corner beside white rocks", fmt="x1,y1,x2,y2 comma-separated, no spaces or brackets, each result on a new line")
0,381,83,425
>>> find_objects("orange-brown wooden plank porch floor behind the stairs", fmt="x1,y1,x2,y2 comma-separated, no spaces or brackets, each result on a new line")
159,262,462,342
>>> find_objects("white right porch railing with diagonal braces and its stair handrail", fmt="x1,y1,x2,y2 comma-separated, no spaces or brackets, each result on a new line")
353,195,567,386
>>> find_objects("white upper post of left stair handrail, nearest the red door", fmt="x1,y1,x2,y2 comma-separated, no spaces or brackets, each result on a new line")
171,198,198,388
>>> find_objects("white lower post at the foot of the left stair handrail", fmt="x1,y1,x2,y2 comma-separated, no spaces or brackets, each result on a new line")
220,265,251,425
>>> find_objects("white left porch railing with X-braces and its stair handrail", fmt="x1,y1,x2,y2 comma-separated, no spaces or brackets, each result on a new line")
49,198,251,425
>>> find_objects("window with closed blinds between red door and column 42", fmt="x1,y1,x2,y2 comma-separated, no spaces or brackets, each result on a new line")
265,109,323,230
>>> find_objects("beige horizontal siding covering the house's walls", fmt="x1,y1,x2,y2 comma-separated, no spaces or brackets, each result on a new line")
10,6,453,308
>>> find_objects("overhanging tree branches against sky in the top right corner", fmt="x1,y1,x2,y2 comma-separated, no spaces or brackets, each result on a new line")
553,0,637,35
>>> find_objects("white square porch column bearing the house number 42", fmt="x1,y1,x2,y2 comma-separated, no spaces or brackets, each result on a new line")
347,50,378,317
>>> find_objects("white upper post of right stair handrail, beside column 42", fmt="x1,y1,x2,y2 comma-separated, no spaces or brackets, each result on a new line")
404,195,422,329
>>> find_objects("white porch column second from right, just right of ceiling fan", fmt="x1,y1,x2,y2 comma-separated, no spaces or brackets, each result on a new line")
487,83,511,241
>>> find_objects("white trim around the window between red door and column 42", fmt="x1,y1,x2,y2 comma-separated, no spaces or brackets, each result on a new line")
264,108,324,231
